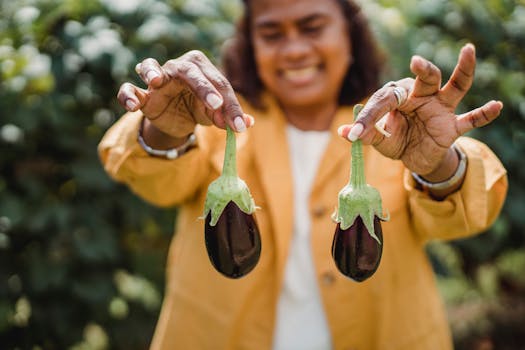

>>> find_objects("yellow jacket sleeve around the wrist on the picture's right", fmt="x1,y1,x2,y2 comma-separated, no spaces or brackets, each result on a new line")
404,137,508,241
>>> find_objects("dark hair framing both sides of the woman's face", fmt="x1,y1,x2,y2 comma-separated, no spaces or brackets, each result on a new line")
222,0,384,108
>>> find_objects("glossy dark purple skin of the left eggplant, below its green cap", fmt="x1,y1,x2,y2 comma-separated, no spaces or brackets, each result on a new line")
204,201,261,278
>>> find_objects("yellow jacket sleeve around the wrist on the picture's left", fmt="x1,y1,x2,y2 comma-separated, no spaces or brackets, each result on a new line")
98,112,214,206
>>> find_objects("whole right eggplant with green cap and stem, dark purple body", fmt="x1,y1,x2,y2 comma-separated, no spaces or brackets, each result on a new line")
332,105,389,282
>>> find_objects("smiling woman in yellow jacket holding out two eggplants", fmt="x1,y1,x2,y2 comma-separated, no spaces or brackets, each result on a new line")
99,0,507,350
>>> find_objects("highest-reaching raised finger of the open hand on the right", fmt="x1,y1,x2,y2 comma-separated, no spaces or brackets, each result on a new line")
442,44,476,108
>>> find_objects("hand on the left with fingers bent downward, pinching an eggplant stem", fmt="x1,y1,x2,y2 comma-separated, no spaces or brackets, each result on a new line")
117,50,254,139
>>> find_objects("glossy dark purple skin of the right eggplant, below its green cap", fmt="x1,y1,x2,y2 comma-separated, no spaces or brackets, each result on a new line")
332,216,383,282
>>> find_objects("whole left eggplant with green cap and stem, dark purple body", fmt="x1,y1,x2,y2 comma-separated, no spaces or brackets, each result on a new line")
203,127,261,278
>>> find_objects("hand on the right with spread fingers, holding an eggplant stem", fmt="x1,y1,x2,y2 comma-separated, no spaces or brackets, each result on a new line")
339,44,503,182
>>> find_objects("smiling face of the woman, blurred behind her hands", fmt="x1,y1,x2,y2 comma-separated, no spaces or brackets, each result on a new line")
251,0,351,108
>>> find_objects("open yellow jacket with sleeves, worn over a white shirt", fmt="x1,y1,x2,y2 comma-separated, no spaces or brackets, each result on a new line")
99,95,507,350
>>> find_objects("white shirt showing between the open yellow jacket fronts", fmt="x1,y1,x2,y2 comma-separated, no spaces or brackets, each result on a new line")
273,125,332,350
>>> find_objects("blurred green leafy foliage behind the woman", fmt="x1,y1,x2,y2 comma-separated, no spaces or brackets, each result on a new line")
0,0,525,349
